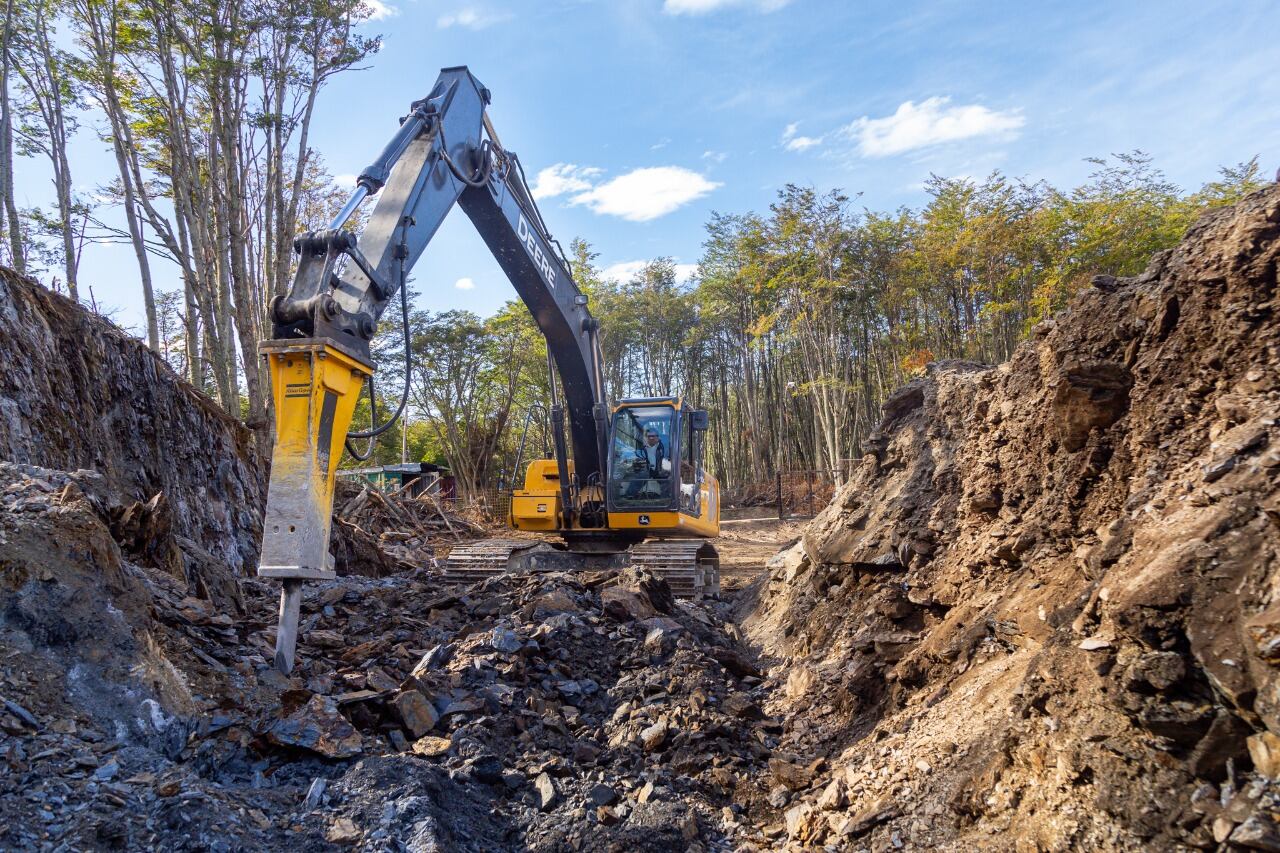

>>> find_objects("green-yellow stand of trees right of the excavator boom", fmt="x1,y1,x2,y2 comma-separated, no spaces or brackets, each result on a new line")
573,151,1262,488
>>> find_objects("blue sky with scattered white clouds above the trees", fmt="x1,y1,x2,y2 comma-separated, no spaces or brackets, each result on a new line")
18,0,1280,328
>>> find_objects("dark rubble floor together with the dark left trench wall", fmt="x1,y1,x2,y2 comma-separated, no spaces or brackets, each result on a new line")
0,270,781,850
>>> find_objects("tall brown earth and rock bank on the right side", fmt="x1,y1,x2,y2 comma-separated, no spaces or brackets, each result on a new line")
745,187,1280,849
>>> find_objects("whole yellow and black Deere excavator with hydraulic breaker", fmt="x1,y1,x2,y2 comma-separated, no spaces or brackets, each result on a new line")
257,67,719,675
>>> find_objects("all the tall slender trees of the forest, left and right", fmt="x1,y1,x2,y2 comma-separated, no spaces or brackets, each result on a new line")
0,0,1262,494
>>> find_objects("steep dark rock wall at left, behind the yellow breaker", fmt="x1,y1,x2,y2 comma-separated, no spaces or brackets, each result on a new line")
0,268,266,574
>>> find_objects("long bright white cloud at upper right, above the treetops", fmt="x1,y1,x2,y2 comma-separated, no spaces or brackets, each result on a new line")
844,97,1025,158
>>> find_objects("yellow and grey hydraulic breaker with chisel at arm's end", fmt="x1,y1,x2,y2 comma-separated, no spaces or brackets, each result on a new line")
257,338,374,675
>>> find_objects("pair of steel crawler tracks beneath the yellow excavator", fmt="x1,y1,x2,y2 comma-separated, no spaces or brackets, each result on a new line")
444,539,719,601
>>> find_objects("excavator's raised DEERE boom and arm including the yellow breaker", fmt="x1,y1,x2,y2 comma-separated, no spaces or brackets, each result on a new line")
259,67,609,674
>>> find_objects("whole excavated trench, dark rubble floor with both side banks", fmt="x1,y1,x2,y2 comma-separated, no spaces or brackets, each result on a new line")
0,187,1280,850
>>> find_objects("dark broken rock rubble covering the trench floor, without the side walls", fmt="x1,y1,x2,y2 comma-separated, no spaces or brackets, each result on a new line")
0,465,781,850
